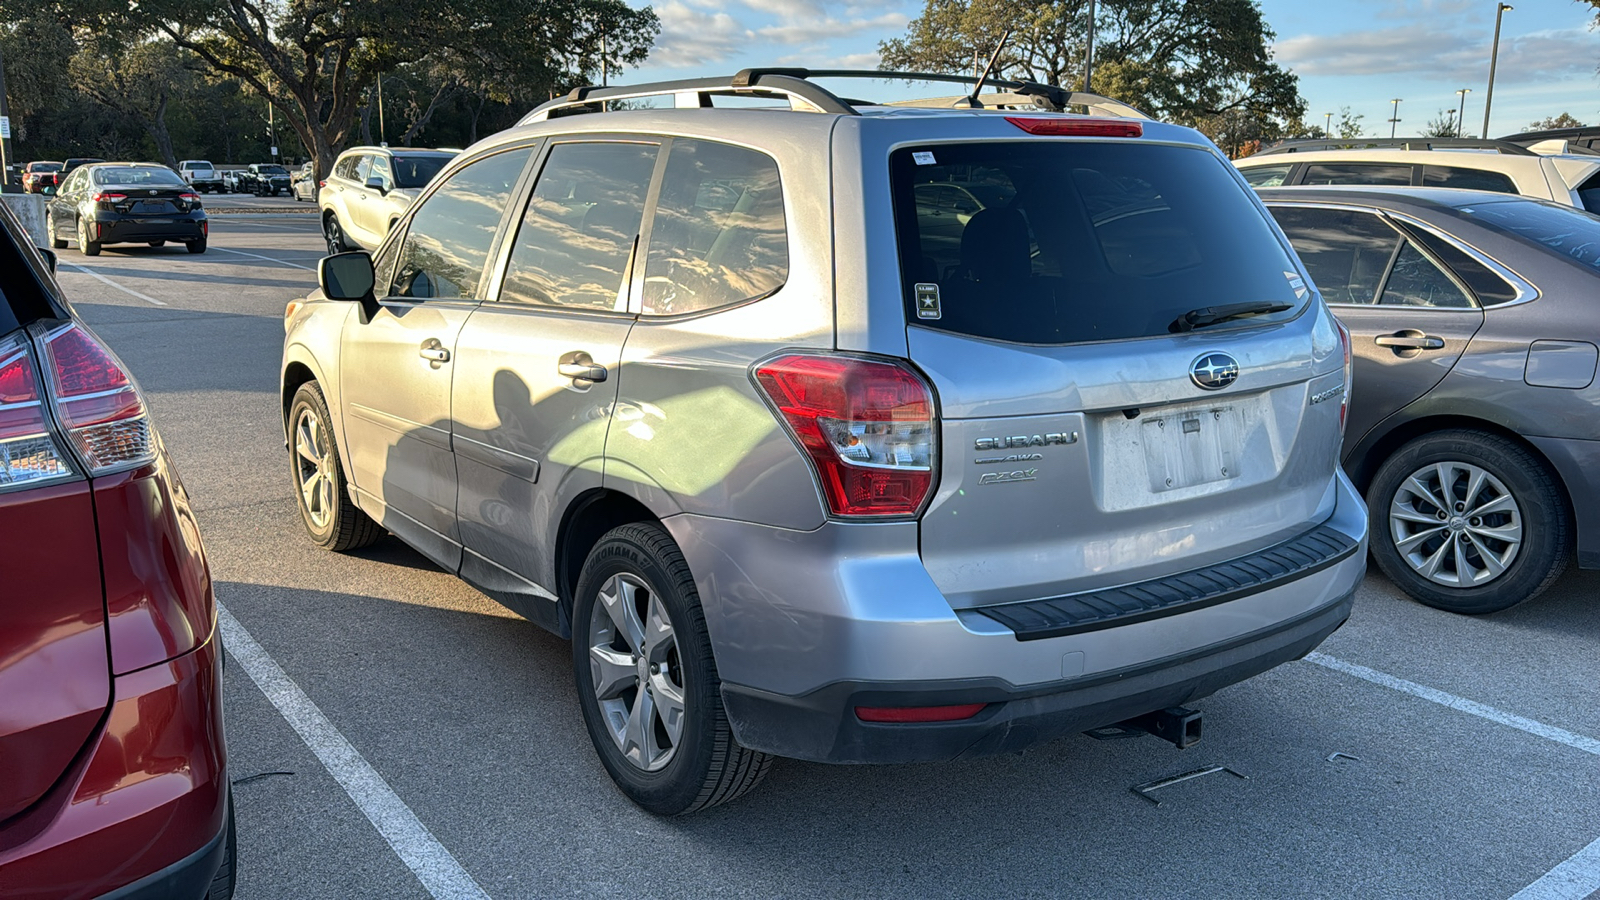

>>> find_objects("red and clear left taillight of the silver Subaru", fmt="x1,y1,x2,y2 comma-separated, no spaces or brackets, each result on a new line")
755,354,938,517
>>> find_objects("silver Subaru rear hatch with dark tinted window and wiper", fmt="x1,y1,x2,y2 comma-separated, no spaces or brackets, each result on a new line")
890,126,1344,609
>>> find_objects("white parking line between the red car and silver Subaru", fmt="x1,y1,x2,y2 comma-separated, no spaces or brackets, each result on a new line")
216,604,488,900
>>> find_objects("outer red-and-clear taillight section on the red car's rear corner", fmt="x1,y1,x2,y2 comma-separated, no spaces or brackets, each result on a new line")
45,323,155,474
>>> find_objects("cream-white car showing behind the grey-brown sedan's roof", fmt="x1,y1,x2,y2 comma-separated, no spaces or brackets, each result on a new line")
1235,138,1600,211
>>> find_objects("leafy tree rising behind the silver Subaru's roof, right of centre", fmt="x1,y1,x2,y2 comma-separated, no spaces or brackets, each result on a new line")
878,0,1305,140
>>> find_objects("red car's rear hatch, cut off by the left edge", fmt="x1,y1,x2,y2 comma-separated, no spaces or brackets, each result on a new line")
0,207,110,823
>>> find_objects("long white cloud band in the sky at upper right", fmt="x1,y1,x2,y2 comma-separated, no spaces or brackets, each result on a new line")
1274,27,1600,83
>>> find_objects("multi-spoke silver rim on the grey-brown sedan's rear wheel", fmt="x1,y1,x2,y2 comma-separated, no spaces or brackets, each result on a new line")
1389,461,1525,588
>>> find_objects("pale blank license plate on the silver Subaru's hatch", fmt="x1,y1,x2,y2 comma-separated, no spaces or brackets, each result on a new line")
1141,407,1245,493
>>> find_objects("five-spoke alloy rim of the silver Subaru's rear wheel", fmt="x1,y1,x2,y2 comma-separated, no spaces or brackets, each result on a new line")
589,573,685,772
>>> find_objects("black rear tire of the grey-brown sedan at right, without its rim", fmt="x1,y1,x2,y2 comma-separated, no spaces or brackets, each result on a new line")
1366,429,1573,615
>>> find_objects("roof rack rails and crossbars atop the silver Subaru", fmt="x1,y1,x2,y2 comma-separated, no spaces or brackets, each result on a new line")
518,69,1149,125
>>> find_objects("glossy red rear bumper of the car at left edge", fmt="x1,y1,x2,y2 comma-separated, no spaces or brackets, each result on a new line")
0,639,227,900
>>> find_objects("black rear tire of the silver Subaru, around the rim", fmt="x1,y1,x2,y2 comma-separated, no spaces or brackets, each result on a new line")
573,522,773,815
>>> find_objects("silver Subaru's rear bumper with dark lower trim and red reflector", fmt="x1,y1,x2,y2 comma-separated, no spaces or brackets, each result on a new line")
666,472,1366,762
